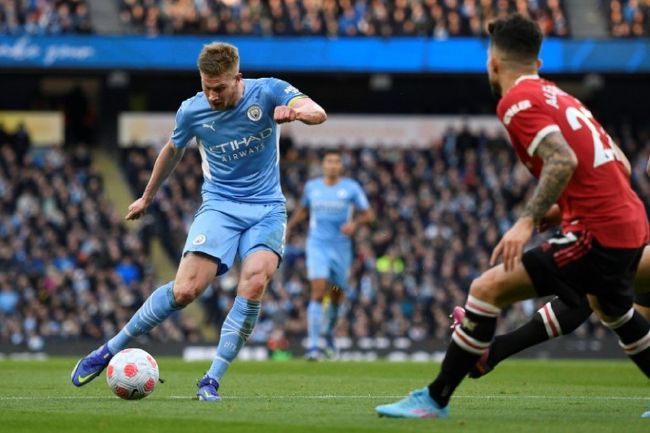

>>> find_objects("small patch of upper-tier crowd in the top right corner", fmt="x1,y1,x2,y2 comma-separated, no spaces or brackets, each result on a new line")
605,0,650,38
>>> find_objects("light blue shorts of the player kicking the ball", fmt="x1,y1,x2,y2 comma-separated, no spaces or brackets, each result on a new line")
183,195,287,275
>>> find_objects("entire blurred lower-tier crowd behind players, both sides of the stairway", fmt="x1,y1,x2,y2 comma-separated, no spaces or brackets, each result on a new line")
6,120,650,349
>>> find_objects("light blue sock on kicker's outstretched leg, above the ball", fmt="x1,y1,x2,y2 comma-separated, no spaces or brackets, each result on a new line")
107,281,183,355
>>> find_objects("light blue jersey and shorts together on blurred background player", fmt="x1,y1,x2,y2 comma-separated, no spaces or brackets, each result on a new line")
301,177,369,288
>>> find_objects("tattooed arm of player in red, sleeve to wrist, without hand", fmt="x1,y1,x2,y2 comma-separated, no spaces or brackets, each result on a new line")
521,132,578,225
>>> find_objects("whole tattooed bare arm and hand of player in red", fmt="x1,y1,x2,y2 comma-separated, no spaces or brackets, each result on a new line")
490,132,578,271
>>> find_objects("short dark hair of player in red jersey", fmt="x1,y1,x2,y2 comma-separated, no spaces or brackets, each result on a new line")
488,14,543,62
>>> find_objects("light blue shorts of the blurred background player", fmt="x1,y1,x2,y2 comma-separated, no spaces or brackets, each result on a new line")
306,240,352,289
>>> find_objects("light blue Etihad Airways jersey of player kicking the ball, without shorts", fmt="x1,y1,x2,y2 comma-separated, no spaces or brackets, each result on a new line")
171,78,306,204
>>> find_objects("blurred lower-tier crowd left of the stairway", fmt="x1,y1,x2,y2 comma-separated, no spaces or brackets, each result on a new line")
0,133,200,350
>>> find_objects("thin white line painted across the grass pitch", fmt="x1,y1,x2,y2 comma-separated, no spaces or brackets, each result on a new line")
0,395,650,401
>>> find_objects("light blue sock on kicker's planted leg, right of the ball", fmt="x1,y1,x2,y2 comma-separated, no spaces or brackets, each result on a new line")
208,296,261,381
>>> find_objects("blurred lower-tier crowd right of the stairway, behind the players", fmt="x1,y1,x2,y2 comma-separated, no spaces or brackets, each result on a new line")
119,122,650,348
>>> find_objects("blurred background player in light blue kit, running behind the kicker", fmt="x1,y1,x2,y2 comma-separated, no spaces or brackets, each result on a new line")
287,150,374,360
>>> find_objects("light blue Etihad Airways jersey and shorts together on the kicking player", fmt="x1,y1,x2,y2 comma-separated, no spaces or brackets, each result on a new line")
171,78,306,275
